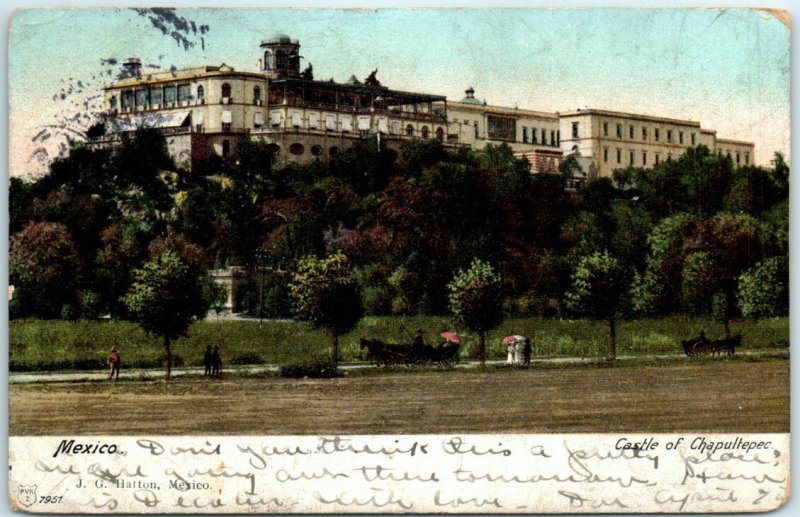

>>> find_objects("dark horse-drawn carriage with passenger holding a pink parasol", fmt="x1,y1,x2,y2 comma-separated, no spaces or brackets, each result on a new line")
361,338,461,367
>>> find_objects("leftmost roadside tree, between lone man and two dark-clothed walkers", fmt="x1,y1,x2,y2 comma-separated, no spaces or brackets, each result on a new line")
124,251,209,379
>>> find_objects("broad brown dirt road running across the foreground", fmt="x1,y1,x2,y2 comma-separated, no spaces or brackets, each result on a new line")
9,359,789,435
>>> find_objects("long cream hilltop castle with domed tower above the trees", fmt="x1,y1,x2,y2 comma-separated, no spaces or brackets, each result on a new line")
95,34,754,178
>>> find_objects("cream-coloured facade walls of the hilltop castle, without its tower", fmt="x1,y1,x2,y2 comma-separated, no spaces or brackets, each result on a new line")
104,65,754,173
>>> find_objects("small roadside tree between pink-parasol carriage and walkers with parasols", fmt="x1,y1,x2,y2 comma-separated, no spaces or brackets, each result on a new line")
447,259,503,366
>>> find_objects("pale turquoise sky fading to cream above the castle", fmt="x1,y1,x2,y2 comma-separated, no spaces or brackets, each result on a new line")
8,9,790,175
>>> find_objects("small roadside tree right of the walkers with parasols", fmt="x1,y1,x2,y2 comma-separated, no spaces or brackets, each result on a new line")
566,252,629,359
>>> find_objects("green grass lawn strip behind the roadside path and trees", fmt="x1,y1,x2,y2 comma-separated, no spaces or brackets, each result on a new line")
9,316,789,371
